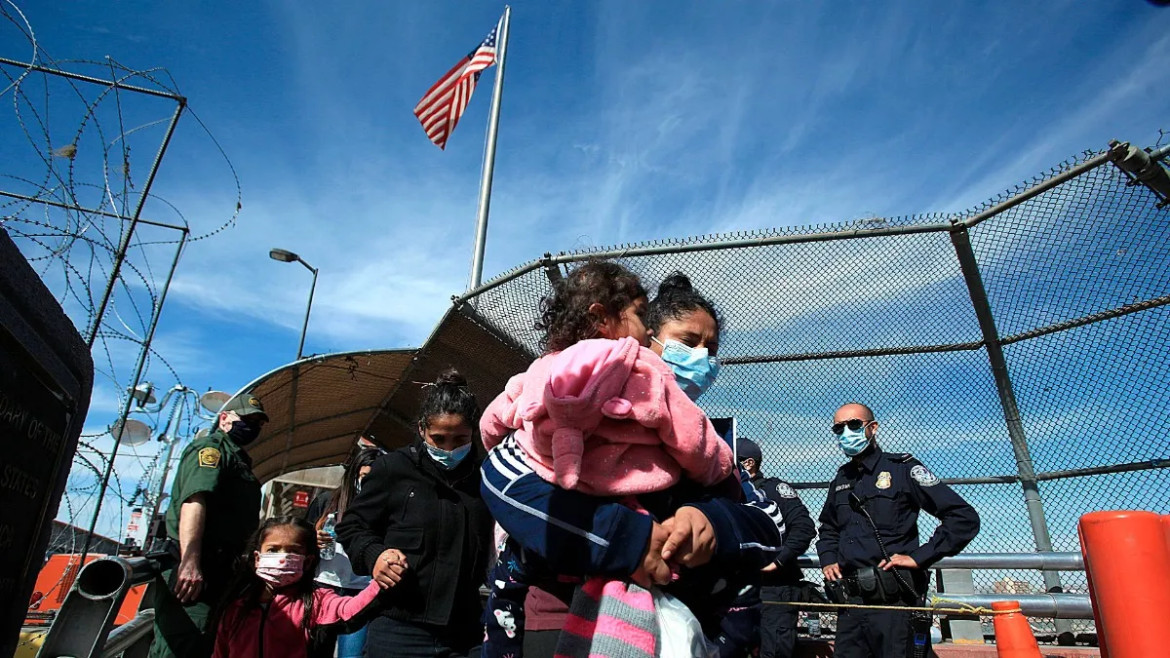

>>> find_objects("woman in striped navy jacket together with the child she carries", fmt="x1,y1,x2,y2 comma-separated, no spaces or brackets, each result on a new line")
481,261,783,656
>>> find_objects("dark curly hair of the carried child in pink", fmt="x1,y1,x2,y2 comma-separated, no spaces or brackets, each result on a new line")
535,260,646,352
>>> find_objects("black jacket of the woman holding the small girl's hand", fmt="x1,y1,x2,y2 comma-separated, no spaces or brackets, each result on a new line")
337,440,491,630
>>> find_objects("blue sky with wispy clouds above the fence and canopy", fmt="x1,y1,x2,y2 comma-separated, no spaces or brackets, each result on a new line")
0,0,1170,543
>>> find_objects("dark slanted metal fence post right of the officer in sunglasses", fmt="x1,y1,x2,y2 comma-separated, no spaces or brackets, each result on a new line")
950,224,1072,636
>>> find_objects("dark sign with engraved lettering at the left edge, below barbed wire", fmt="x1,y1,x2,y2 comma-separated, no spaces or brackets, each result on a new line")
0,229,94,656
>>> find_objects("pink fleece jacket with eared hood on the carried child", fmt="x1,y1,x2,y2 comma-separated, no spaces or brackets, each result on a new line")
480,338,734,495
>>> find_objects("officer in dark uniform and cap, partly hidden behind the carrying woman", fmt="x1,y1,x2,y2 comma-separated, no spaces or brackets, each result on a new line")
736,439,817,658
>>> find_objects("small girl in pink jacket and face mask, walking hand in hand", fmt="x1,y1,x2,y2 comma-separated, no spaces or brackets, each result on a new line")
212,516,381,658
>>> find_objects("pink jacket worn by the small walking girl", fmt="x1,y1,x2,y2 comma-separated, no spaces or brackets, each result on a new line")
212,582,381,658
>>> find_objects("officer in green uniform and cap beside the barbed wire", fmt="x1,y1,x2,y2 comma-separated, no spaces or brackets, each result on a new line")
150,396,268,658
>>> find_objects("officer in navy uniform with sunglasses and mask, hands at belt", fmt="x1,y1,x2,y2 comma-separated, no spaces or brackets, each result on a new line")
817,404,979,658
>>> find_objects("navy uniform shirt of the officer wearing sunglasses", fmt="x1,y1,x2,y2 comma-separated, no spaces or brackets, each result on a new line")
817,446,979,569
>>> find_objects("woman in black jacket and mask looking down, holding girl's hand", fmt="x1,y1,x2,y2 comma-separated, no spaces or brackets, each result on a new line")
337,370,491,658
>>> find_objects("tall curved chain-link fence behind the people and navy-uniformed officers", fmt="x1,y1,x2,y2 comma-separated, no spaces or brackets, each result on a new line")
367,139,1170,628
